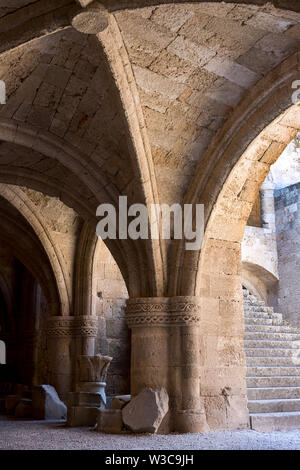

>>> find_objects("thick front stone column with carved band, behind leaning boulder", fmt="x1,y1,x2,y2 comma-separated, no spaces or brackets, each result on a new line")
127,297,207,432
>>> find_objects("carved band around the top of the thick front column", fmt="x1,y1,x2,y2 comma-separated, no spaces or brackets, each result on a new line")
126,297,201,328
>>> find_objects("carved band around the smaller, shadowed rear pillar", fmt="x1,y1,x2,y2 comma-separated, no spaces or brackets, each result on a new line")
46,316,98,338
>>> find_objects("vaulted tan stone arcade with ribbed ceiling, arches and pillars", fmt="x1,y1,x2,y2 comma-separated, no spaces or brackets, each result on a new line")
0,0,300,433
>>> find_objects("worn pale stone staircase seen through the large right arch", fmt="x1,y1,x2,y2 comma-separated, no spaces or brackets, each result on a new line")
243,289,300,431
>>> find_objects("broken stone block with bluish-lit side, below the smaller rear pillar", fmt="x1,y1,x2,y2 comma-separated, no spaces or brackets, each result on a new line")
32,385,67,419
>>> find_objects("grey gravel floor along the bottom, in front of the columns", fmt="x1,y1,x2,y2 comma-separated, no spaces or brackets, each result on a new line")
0,418,300,450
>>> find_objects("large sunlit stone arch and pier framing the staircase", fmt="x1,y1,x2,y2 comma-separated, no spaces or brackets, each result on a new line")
165,54,300,428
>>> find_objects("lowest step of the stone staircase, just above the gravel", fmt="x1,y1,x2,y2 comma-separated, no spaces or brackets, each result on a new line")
250,411,300,431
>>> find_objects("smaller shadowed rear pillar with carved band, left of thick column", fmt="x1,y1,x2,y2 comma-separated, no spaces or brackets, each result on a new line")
47,316,97,398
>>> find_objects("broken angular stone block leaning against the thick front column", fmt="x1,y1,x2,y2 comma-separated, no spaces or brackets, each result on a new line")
122,387,169,433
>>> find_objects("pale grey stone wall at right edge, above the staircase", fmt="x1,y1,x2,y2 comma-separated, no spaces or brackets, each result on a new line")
275,183,300,325
